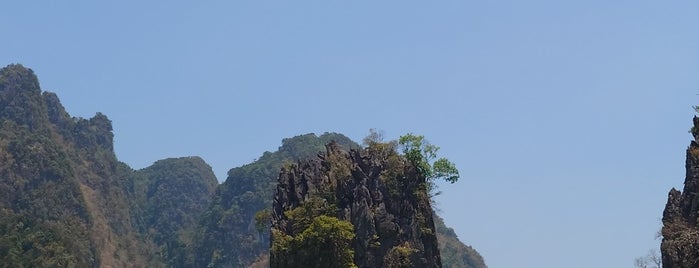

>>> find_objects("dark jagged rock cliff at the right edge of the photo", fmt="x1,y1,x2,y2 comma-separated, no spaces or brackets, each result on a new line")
660,116,699,268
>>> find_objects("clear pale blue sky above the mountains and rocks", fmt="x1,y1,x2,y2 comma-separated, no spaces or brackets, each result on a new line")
0,0,699,268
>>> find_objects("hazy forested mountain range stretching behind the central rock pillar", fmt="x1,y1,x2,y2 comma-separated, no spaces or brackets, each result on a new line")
0,64,484,267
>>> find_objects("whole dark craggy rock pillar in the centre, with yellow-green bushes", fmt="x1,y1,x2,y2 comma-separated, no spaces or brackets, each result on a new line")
270,143,442,267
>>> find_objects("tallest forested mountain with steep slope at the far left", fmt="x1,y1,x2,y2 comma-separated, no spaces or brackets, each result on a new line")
0,65,152,267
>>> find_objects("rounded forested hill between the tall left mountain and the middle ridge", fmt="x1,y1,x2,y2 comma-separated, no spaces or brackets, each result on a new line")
134,157,218,267
